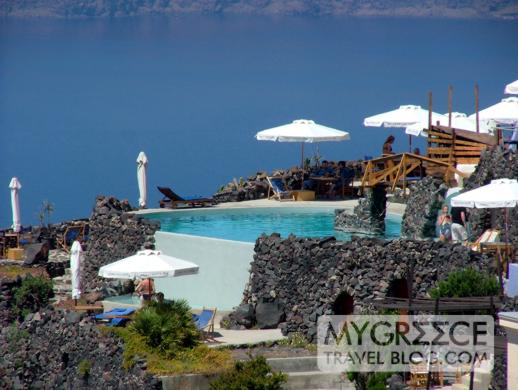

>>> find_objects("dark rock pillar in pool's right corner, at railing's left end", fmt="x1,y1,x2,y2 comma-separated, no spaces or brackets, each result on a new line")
335,186,387,234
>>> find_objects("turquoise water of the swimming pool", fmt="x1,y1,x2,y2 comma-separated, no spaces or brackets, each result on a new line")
145,207,401,242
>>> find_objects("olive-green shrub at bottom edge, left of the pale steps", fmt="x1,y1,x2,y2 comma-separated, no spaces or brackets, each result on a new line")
210,356,287,390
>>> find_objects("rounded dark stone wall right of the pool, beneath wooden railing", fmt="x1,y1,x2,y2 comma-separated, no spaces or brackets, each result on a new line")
401,176,448,240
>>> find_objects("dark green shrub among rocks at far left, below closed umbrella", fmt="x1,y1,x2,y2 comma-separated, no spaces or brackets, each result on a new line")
13,275,54,318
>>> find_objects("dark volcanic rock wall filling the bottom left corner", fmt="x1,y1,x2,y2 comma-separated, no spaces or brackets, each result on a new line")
0,308,161,389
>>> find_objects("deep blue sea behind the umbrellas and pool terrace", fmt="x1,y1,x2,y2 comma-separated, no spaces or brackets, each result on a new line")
0,16,518,226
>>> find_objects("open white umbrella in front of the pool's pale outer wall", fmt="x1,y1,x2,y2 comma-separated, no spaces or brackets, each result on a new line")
99,250,199,279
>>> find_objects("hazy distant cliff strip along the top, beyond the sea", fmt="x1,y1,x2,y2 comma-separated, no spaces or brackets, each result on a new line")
0,0,518,19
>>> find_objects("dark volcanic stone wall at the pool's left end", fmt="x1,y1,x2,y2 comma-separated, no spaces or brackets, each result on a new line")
82,196,160,291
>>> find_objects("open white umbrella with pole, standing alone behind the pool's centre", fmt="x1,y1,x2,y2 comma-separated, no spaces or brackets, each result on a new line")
255,119,350,168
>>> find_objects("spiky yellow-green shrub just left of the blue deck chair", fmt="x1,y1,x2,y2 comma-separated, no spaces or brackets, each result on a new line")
130,300,200,356
